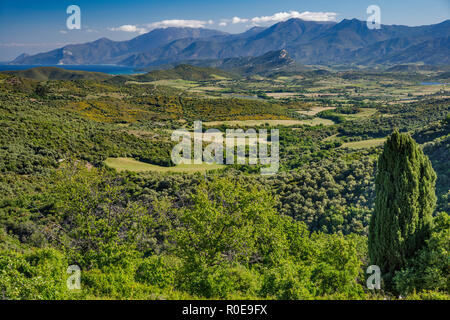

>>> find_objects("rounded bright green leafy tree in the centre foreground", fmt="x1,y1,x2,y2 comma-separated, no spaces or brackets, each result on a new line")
172,179,285,266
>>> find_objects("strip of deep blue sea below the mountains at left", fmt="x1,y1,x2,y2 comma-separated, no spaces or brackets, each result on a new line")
0,64,145,75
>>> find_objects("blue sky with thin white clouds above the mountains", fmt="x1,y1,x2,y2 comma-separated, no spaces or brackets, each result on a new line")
0,0,450,61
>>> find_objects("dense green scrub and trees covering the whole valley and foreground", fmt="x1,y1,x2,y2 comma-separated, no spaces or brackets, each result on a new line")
0,68,450,299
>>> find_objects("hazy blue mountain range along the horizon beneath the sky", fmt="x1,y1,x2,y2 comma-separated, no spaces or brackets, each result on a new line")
11,19,450,69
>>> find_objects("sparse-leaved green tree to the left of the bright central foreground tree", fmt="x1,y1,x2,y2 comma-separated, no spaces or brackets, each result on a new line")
48,167,154,269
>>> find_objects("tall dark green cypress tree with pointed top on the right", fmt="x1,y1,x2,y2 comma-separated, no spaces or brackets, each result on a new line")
369,131,436,285
